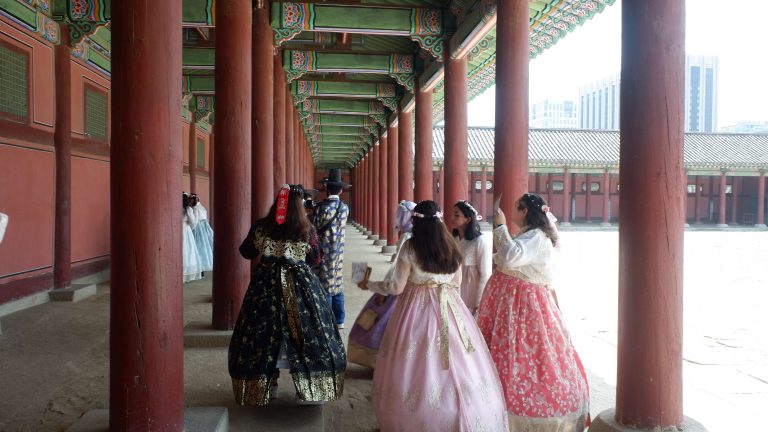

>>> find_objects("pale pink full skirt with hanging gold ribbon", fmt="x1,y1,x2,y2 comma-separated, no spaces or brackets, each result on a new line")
373,283,508,432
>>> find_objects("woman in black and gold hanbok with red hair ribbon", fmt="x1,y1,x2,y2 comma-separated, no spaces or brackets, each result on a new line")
229,185,347,405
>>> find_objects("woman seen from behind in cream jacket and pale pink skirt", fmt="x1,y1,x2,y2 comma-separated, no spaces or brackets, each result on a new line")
360,201,507,432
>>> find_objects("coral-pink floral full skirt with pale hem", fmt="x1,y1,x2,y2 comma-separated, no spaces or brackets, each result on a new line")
477,271,589,432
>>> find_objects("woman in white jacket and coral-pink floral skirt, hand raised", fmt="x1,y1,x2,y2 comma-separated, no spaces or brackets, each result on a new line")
477,194,589,432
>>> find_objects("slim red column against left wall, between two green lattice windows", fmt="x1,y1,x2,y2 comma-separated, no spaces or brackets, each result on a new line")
53,24,72,289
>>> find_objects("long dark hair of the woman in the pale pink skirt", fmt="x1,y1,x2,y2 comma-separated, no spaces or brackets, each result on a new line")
408,201,462,274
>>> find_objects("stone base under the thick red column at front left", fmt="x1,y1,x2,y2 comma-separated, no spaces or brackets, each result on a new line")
67,407,229,432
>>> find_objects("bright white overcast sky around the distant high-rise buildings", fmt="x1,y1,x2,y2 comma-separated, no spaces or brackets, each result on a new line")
469,0,768,128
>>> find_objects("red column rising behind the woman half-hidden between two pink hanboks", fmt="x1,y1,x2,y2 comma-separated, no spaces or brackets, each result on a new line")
441,56,468,221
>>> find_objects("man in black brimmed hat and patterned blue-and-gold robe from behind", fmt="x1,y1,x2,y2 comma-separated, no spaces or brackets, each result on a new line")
312,169,349,329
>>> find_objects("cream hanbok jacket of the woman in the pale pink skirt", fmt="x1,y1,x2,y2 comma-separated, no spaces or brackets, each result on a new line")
368,239,461,295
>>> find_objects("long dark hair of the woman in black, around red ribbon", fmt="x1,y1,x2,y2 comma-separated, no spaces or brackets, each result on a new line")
256,185,312,241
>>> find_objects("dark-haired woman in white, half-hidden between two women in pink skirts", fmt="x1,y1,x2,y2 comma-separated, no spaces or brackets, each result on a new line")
451,200,491,315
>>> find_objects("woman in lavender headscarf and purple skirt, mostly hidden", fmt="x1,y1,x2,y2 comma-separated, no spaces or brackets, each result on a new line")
347,201,416,369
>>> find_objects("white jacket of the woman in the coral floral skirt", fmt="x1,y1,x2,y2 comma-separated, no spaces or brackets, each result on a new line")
493,225,555,285
